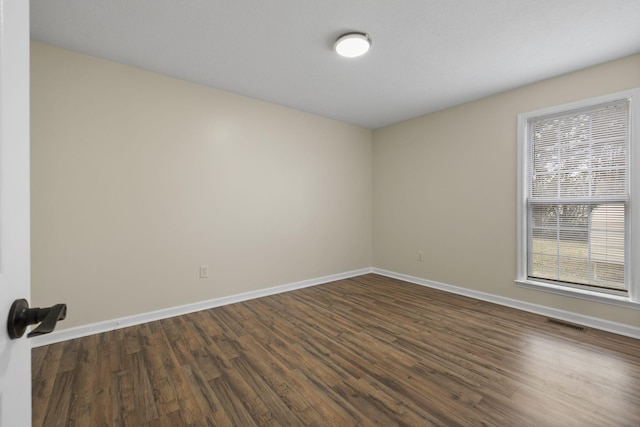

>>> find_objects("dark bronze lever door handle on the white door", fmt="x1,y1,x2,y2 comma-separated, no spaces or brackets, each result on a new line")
7,299,67,339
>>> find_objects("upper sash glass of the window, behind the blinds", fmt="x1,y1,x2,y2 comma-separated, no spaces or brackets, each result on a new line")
529,100,629,198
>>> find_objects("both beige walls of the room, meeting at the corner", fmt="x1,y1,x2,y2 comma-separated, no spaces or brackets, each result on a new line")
31,38,640,329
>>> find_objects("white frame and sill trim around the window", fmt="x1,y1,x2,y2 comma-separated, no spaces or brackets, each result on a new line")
515,88,640,309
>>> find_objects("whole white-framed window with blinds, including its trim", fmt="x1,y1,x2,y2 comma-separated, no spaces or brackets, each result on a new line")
516,89,640,308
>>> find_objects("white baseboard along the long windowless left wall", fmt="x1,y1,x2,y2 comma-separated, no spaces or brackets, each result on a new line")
30,268,373,347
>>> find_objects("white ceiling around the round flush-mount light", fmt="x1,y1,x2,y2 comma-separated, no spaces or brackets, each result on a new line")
31,0,640,129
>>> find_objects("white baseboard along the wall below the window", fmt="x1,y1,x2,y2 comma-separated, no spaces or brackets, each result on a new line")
372,268,640,339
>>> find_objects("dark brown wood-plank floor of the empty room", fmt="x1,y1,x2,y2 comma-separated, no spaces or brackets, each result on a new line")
33,274,640,427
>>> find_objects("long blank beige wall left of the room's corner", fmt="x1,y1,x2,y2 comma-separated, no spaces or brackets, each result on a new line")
31,43,372,329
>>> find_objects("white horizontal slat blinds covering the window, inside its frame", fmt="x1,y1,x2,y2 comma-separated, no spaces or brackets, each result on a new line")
527,99,629,290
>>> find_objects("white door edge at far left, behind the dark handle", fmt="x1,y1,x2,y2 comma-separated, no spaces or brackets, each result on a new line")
0,0,31,427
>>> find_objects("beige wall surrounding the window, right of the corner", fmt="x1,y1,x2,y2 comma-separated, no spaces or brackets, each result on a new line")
373,55,640,327
